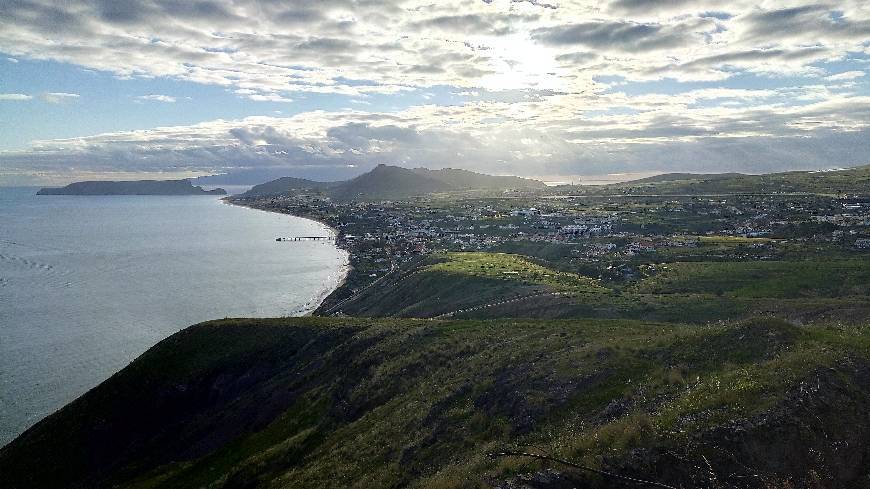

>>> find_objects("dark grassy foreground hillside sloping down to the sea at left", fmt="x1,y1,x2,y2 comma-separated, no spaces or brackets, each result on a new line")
0,318,870,488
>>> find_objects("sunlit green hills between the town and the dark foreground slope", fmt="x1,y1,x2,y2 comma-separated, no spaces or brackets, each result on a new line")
336,250,870,323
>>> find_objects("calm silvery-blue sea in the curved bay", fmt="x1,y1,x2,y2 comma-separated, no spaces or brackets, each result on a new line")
0,188,347,446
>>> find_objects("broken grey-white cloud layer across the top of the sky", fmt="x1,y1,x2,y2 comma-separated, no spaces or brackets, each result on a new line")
0,0,870,94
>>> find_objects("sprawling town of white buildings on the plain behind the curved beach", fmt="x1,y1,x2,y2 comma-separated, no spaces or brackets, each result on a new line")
232,187,870,316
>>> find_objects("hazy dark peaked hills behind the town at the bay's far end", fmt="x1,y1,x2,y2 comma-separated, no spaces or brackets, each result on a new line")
242,165,546,200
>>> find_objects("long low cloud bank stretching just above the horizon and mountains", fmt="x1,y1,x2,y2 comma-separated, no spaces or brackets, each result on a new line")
0,89,870,183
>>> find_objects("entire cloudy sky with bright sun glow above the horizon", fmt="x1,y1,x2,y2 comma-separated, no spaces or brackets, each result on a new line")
0,0,870,185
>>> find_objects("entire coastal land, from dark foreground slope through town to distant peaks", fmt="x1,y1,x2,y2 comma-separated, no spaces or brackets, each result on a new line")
8,167,870,489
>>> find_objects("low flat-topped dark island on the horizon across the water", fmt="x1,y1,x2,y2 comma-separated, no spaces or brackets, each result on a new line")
36,180,227,195
